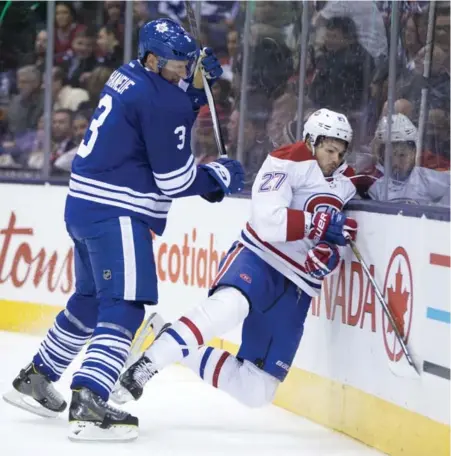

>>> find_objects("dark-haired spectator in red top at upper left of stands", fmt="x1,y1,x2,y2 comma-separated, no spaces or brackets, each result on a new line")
55,2,86,63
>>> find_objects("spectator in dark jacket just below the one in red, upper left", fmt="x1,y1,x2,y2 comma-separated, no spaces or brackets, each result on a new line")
63,30,97,87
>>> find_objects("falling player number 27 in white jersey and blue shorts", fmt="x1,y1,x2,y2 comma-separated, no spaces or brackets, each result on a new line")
113,109,357,407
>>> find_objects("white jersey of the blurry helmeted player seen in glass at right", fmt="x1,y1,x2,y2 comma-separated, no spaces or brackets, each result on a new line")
368,166,450,206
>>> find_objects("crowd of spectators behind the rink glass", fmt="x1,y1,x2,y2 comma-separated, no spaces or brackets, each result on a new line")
0,1,450,207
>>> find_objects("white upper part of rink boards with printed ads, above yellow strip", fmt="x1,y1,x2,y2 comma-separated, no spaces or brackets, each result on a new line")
0,184,451,424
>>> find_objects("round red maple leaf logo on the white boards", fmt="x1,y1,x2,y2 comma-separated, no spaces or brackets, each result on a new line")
382,247,413,362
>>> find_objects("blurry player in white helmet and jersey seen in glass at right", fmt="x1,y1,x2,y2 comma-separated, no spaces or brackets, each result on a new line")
368,114,450,206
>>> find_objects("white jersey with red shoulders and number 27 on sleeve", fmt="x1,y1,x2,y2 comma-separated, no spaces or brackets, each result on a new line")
240,142,356,296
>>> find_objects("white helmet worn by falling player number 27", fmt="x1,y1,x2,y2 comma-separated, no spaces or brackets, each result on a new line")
302,108,352,153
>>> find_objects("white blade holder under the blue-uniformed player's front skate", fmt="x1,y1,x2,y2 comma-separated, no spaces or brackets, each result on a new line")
68,421,138,442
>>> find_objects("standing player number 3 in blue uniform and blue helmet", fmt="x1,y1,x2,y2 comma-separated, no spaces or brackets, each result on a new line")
4,19,243,441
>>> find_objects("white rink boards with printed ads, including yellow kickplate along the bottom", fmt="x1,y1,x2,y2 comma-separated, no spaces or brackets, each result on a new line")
0,184,450,456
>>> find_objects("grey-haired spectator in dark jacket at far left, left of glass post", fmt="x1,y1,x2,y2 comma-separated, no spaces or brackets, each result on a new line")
7,65,44,139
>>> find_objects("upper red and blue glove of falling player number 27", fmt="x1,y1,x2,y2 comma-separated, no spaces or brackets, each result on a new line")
308,212,357,245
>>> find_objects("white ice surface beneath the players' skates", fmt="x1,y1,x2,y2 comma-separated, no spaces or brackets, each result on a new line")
0,332,382,456
